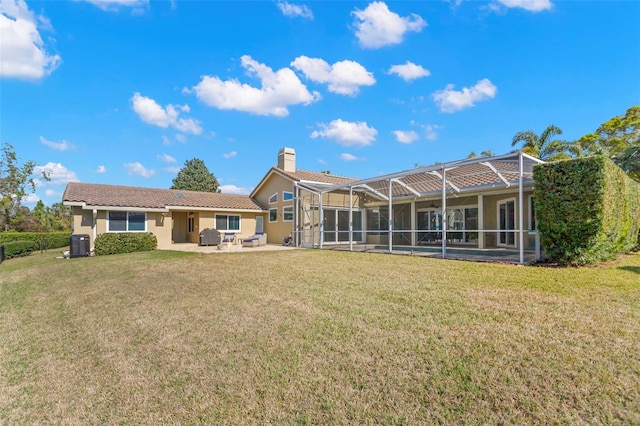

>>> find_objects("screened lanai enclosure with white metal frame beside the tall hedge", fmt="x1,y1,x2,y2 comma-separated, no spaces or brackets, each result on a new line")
294,152,542,263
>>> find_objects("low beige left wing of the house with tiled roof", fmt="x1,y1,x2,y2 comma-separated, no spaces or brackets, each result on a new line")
62,182,266,248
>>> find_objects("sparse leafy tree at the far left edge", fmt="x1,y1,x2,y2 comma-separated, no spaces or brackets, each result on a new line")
0,143,49,231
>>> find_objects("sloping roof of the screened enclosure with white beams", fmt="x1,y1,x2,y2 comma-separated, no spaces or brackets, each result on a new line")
301,151,543,200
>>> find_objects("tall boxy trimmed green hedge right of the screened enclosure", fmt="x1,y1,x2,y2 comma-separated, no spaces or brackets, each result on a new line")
533,156,640,265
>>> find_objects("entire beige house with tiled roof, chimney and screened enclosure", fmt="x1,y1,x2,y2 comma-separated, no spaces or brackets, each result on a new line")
63,148,541,262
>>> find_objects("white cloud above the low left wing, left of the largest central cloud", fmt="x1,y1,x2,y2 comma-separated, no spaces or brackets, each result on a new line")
131,92,202,135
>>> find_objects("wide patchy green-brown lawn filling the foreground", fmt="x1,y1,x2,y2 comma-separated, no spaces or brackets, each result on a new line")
0,250,640,425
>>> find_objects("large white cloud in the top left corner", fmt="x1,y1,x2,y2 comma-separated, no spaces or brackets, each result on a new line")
0,0,62,80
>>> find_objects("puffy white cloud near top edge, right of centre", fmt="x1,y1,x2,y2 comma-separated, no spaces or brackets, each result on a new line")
351,2,427,49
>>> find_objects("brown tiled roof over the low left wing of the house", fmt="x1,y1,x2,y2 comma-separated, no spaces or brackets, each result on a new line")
62,182,266,211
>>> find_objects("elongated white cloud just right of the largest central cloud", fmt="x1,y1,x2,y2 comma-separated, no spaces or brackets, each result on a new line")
291,56,376,95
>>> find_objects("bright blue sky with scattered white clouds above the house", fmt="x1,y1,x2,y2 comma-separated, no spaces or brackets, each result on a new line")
0,0,640,205
